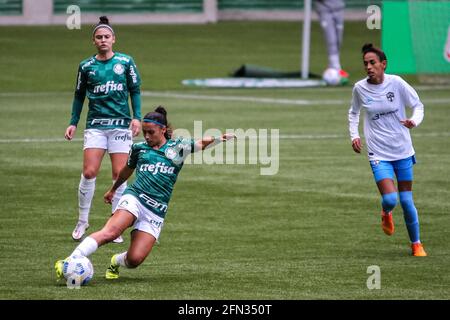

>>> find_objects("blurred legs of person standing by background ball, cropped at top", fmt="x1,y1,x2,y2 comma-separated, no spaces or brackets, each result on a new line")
314,0,349,79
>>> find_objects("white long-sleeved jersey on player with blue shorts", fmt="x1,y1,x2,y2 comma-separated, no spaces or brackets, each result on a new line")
348,74,424,161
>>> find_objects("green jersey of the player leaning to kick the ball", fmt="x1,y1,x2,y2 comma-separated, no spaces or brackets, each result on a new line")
123,138,195,218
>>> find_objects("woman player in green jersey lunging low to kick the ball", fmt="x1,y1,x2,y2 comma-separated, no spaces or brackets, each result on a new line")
55,107,235,279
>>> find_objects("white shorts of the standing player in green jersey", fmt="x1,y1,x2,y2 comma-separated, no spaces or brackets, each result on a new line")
83,129,133,153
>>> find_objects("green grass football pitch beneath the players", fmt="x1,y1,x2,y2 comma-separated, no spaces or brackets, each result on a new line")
0,22,450,300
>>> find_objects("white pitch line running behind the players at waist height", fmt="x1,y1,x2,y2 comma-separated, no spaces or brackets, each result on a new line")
0,132,450,143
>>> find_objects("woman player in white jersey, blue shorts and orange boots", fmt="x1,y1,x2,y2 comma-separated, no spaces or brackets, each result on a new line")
348,44,427,257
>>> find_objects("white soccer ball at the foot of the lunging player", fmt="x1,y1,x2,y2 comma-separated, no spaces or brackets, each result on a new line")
63,255,94,287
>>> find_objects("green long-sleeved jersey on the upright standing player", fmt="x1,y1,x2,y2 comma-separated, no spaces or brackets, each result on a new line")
70,52,141,129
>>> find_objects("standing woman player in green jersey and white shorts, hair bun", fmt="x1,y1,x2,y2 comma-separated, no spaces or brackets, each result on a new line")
65,16,141,243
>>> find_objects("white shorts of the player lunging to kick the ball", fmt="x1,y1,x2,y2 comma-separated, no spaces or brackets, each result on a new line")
116,194,164,240
